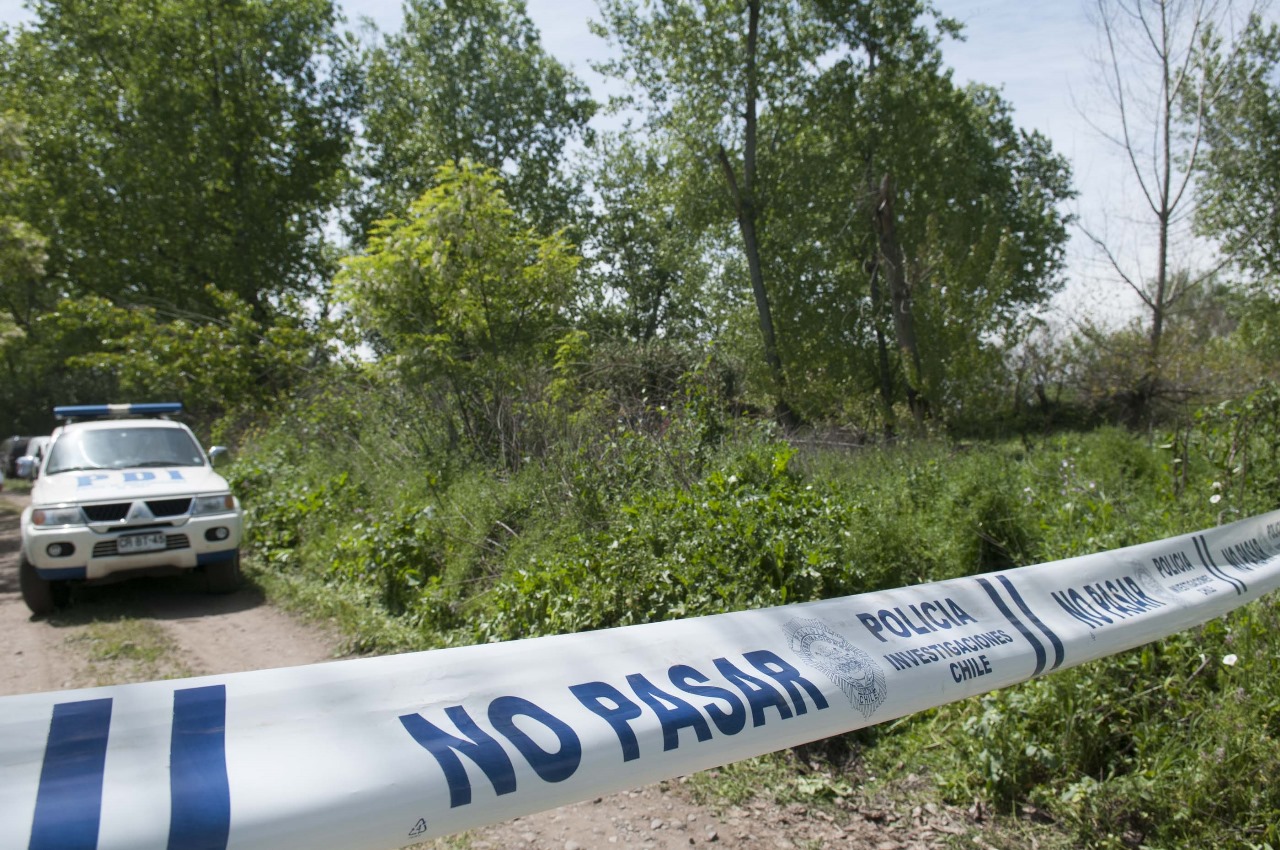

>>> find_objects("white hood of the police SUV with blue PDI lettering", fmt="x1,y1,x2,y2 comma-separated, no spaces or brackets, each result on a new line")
31,466,230,504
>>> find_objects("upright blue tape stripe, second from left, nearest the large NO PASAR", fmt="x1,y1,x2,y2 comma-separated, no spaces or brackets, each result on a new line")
169,685,232,850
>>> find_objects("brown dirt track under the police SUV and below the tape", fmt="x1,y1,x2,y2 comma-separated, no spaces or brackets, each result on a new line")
0,492,993,850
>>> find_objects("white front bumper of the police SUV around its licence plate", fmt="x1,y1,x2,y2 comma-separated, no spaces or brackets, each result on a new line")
22,513,243,581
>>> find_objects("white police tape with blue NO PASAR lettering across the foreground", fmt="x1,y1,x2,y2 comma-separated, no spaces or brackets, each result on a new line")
0,512,1280,850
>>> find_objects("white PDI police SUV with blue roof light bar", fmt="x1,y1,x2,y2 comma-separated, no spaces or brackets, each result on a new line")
18,403,243,614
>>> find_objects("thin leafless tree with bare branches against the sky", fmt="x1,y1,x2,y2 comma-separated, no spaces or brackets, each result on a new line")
1085,0,1254,415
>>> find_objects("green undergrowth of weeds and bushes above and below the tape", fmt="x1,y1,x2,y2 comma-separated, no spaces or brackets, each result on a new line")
232,384,1280,849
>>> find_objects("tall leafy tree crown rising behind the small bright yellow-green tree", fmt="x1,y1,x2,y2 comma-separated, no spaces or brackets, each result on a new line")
356,0,595,237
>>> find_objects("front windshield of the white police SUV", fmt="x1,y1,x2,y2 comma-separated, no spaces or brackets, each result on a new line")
45,426,205,475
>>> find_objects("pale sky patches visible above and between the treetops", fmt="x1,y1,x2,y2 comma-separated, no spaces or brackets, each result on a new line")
0,0,1259,324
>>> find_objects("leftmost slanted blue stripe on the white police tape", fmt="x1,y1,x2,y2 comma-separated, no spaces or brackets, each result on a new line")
27,699,111,850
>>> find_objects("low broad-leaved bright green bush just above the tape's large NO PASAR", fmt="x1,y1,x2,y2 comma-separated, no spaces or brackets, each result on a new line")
481,445,847,639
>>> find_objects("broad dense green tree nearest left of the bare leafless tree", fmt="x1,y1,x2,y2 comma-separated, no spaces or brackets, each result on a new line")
767,32,1073,426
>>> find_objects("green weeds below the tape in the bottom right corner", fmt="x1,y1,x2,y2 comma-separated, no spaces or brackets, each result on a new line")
872,600,1280,849
